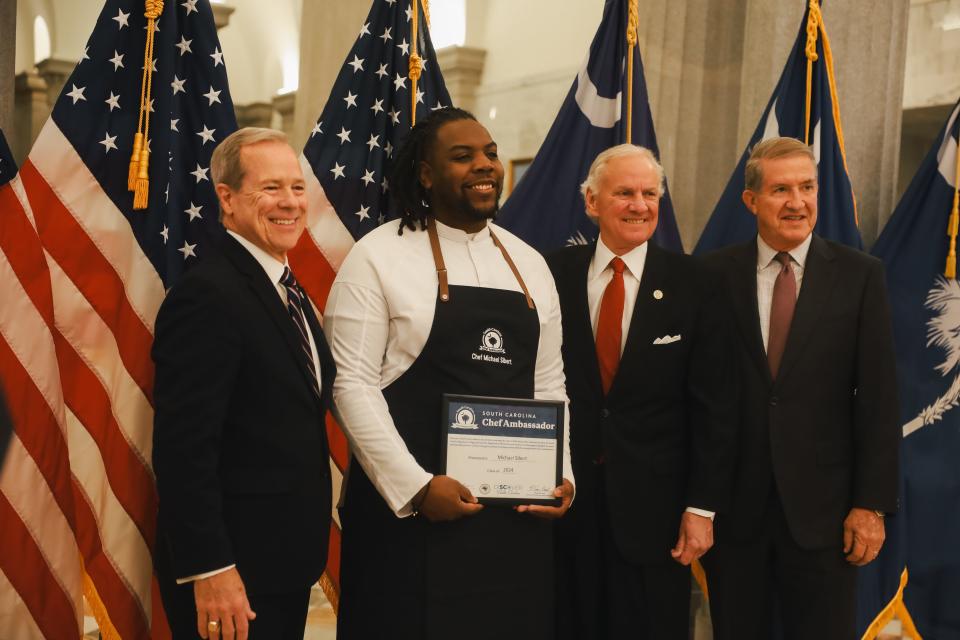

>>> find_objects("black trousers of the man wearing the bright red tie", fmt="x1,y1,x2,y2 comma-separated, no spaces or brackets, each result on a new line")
557,466,690,640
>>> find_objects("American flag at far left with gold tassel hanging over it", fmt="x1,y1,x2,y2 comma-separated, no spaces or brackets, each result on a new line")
0,0,236,638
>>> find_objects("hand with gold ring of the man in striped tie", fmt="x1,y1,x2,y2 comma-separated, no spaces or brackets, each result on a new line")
193,567,257,640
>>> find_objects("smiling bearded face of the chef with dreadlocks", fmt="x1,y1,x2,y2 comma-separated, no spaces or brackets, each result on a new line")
419,119,503,232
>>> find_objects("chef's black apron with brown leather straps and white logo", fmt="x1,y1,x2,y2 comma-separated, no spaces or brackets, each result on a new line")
337,220,554,640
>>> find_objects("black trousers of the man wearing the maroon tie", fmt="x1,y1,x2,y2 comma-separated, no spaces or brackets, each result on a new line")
703,497,857,640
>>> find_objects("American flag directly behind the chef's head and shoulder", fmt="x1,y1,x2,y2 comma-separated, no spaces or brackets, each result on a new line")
289,0,450,606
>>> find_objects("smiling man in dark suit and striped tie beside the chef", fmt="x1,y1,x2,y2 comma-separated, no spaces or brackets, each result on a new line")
153,129,335,640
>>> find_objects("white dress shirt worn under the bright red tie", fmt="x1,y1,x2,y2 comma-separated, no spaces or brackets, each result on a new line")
587,238,715,520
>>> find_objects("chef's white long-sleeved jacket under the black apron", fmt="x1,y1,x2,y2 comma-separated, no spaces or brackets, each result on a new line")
324,220,574,517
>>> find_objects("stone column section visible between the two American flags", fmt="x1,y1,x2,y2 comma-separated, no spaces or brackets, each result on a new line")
290,0,370,149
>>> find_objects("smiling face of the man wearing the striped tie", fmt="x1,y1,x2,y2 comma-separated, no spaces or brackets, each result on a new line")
216,141,307,262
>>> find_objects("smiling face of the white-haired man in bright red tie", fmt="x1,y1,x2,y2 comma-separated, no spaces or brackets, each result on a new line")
585,156,660,256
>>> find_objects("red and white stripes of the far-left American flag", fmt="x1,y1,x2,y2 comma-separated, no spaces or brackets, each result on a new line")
0,119,169,639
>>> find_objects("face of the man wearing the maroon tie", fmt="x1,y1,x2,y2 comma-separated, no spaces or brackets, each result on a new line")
743,154,818,251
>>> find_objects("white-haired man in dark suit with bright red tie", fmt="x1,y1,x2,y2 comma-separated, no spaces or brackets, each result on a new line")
548,145,736,640
